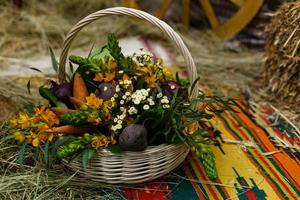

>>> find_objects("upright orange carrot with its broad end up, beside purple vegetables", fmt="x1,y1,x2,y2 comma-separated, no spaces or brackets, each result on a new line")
73,73,89,102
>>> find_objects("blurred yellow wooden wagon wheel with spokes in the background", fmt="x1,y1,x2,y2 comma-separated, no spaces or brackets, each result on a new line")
123,0,264,40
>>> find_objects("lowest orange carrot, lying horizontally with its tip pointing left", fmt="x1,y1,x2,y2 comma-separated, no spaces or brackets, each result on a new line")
45,125,93,134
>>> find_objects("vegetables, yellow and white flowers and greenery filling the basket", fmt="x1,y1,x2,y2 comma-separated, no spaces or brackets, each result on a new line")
10,34,229,179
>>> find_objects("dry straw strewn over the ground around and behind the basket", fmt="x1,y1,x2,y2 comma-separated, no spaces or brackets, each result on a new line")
0,0,297,199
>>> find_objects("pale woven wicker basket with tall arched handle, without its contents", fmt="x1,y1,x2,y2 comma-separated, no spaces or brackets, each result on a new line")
58,7,198,184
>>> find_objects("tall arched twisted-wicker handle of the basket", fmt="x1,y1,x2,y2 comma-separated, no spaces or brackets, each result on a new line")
58,7,198,96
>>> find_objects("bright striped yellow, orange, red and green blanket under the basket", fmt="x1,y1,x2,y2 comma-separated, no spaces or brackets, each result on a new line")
124,101,300,200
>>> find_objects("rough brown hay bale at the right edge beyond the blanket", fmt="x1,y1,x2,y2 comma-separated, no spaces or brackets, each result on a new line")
263,1,300,104
